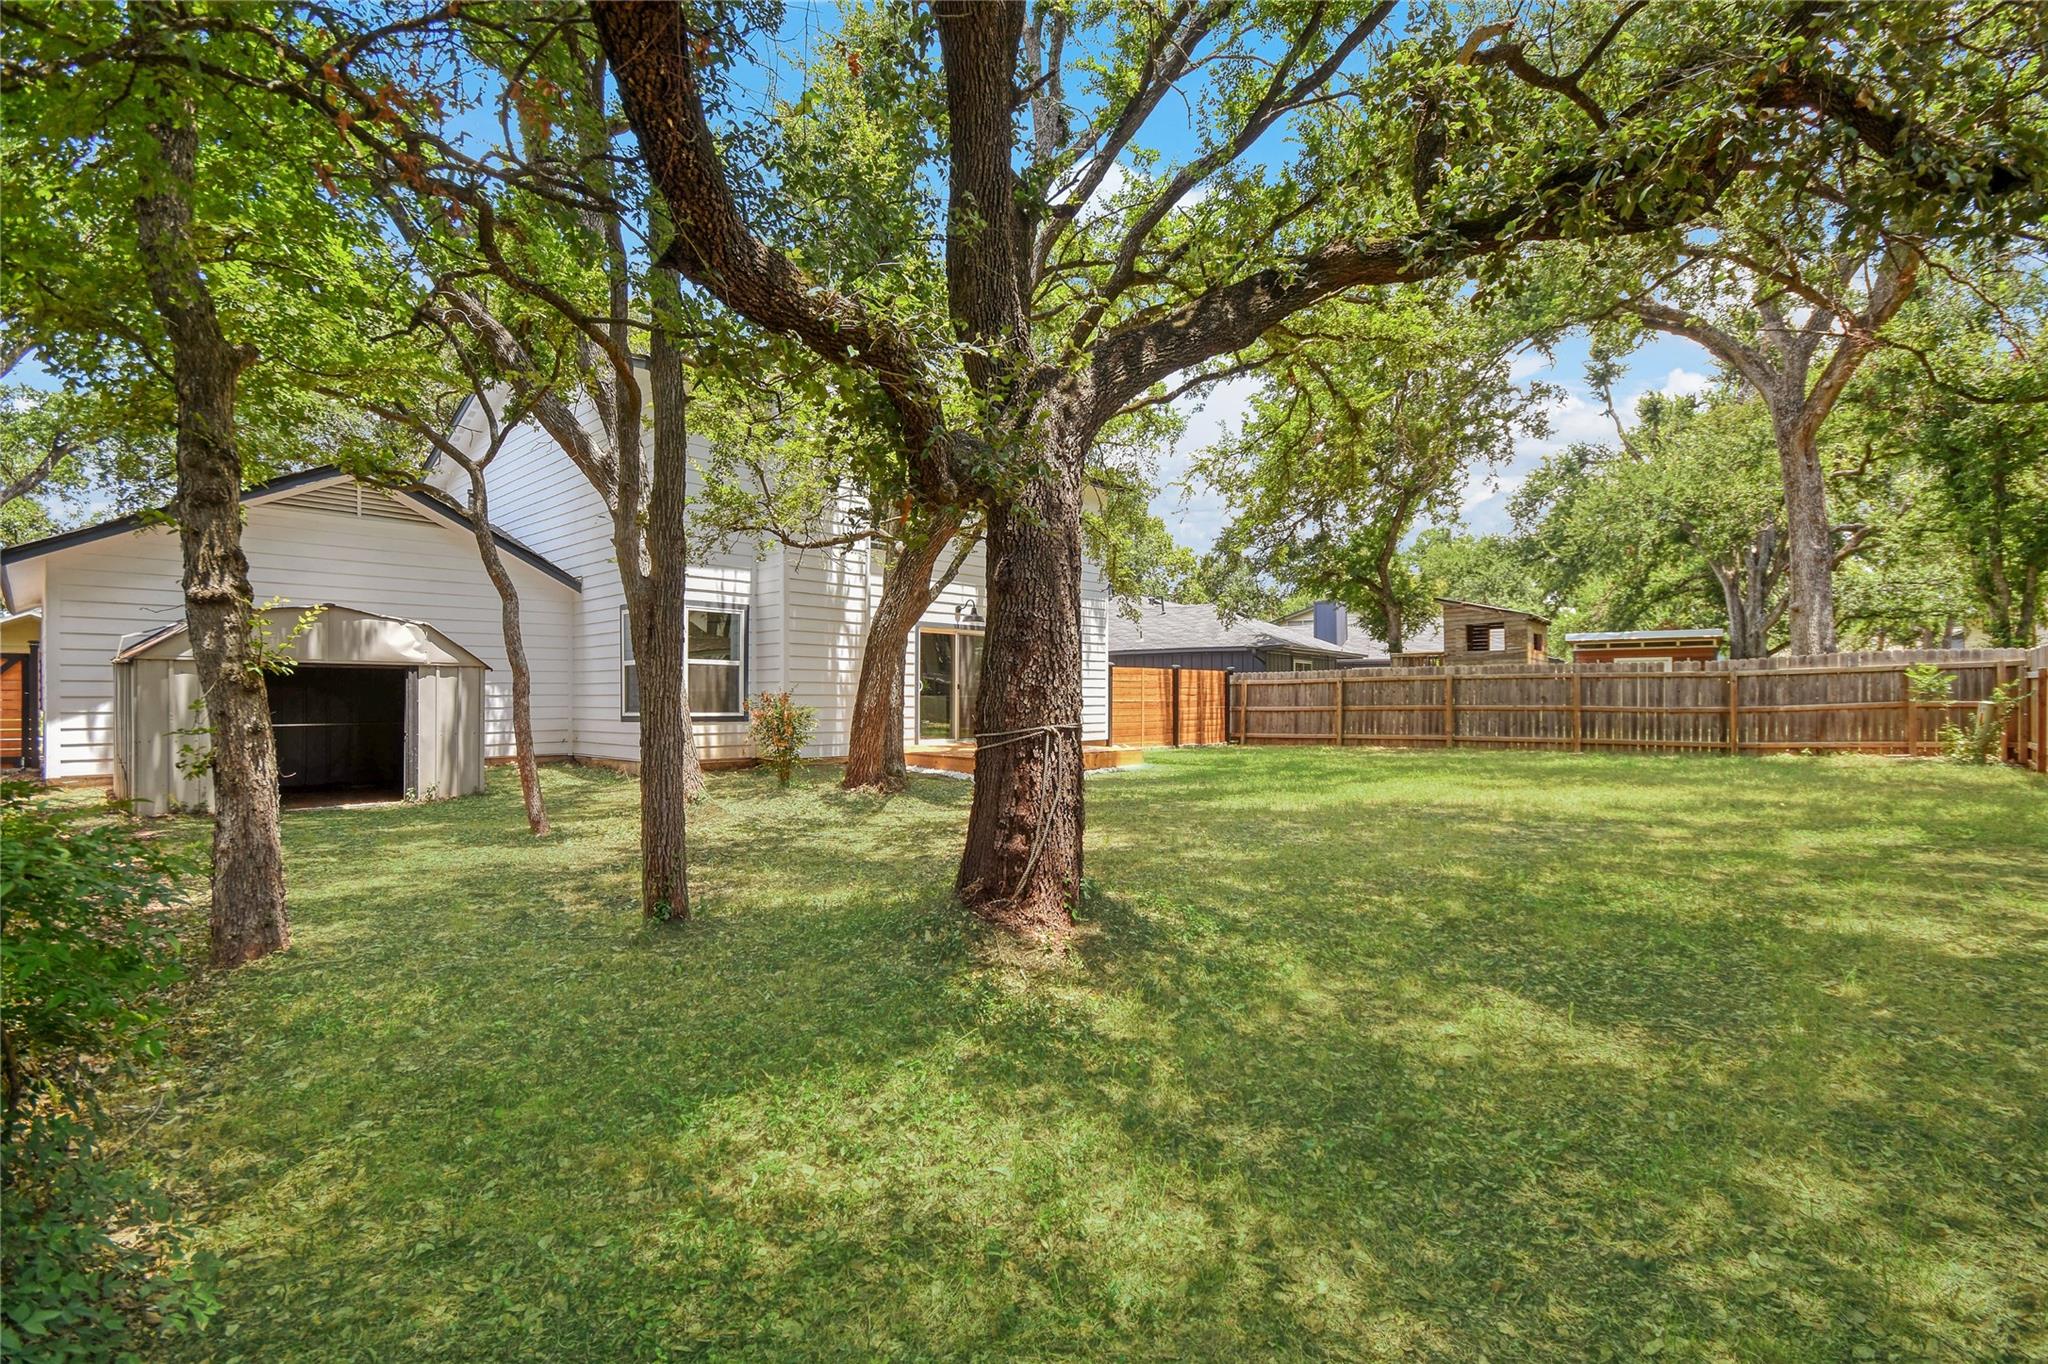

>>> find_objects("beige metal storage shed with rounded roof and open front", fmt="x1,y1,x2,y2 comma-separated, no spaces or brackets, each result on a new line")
113,604,483,815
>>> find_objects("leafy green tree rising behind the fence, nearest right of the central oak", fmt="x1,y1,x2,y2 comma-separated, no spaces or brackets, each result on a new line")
1198,287,1556,653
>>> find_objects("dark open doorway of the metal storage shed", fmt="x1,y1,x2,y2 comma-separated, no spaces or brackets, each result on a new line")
268,664,410,797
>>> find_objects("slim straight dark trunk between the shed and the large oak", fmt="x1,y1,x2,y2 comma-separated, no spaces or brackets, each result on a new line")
621,284,705,920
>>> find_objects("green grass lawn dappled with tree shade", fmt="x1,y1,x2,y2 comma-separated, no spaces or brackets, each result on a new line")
121,750,2048,1362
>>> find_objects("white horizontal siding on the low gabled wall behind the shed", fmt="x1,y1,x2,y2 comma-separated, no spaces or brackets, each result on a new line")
45,483,575,776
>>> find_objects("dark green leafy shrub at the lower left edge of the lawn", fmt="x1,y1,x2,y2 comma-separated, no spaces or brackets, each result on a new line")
0,782,211,1360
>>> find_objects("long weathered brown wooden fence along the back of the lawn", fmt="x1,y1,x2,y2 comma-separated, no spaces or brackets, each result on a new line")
1231,649,2048,770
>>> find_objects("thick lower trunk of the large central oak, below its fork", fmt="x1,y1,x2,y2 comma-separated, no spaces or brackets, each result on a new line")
954,442,1081,938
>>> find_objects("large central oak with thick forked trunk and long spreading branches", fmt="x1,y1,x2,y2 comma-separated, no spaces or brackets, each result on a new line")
594,0,2038,934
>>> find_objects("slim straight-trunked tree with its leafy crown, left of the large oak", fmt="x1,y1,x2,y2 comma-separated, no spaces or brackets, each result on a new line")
290,15,705,920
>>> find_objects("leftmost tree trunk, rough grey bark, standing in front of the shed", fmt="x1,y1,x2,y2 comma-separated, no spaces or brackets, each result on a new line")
135,104,291,967
